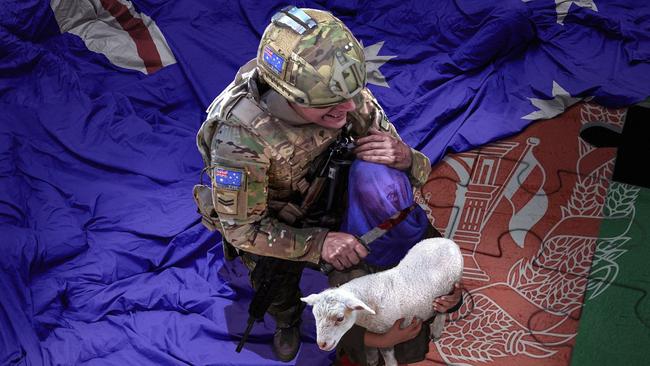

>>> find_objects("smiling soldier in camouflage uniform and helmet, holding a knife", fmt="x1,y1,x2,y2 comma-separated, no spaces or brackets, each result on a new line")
194,6,459,361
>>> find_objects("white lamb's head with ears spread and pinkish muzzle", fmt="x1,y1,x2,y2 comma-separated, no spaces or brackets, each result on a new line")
300,288,375,351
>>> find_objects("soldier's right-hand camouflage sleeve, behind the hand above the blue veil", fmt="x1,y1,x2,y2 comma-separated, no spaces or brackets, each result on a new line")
354,88,431,187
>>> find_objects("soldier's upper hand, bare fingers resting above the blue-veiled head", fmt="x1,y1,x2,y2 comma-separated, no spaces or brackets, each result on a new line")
354,128,411,170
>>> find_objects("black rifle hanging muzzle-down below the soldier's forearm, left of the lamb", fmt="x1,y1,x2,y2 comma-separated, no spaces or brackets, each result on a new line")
236,257,305,353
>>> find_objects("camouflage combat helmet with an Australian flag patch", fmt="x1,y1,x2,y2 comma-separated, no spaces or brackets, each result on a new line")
257,6,366,107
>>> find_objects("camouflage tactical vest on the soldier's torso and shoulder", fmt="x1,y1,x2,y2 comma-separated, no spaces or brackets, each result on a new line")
194,60,340,232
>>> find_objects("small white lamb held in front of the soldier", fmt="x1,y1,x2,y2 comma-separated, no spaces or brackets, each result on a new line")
301,238,463,366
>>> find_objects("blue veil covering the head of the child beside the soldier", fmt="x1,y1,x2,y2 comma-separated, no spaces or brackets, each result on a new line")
341,160,429,267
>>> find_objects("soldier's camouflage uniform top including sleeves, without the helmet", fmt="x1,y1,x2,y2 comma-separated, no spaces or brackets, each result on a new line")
195,61,431,264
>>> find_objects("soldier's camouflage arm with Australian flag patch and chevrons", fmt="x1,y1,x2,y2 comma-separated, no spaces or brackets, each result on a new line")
210,123,327,263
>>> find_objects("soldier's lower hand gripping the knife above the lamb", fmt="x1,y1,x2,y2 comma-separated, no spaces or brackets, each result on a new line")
321,231,368,271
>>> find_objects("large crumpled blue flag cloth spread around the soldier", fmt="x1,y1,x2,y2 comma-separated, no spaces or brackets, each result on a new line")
0,0,650,365
